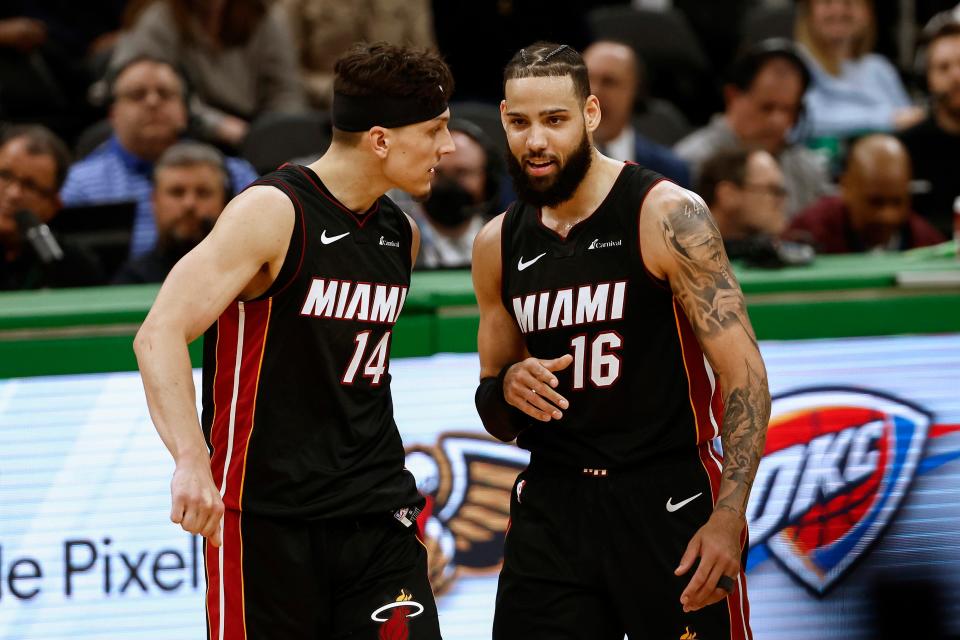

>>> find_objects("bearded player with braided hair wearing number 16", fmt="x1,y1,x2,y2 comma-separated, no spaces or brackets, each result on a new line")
473,42,770,640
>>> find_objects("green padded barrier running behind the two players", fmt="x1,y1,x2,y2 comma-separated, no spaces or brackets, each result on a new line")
0,243,960,378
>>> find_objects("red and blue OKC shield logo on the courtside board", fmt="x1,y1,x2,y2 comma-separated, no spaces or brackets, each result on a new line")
747,388,931,595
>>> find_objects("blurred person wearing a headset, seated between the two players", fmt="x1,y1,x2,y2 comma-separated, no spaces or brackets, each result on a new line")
402,119,504,269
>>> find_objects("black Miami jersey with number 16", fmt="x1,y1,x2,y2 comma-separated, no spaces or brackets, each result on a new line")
501,164,722,468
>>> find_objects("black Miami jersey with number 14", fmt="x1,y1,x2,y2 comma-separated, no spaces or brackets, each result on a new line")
202,165,420,518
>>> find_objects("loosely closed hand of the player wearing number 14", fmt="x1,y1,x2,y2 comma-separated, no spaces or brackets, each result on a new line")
170,456,223,547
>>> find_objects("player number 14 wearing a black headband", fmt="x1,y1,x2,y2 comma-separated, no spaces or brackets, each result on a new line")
134,43,454,640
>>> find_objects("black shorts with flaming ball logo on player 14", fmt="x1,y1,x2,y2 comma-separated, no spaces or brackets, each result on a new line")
204,510,440,640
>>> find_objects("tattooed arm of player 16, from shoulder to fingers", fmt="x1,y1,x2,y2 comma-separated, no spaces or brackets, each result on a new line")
640,183,770,610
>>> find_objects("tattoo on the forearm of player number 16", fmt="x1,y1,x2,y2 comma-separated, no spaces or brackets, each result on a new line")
716,360,770,516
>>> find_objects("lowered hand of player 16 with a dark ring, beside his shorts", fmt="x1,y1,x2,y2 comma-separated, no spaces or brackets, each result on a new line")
674,509,745,612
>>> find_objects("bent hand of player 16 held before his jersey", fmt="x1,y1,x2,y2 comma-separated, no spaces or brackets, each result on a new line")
503,353,573,422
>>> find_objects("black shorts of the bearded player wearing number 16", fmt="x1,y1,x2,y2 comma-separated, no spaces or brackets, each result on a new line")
493,445,752,640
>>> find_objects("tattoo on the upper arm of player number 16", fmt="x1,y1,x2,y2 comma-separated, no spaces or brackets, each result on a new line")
662,196,756,344
